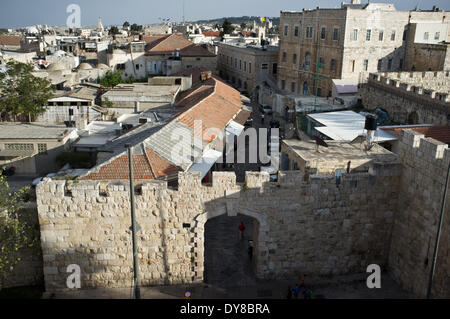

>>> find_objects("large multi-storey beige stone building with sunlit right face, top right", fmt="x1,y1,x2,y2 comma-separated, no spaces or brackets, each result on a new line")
278,1,448,96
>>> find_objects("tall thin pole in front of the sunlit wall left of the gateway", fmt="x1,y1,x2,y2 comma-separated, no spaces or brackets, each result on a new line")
125,144,141,299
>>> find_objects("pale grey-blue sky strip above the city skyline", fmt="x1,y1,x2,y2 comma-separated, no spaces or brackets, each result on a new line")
0,0,450,28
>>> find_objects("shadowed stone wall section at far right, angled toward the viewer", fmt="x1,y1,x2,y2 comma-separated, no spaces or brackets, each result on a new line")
388,130,450,298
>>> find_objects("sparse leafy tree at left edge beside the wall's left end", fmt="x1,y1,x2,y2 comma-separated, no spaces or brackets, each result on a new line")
0,168,37,290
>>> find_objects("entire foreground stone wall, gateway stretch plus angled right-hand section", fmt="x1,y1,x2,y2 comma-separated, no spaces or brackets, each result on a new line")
37,130,450,298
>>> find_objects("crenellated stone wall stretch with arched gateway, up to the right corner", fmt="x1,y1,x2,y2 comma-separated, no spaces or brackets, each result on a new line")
37,163,399,291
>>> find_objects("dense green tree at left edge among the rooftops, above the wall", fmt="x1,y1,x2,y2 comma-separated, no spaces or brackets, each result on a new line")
0,61,54,122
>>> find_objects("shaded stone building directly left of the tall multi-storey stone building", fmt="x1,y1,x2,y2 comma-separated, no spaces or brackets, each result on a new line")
217,43,278,92
